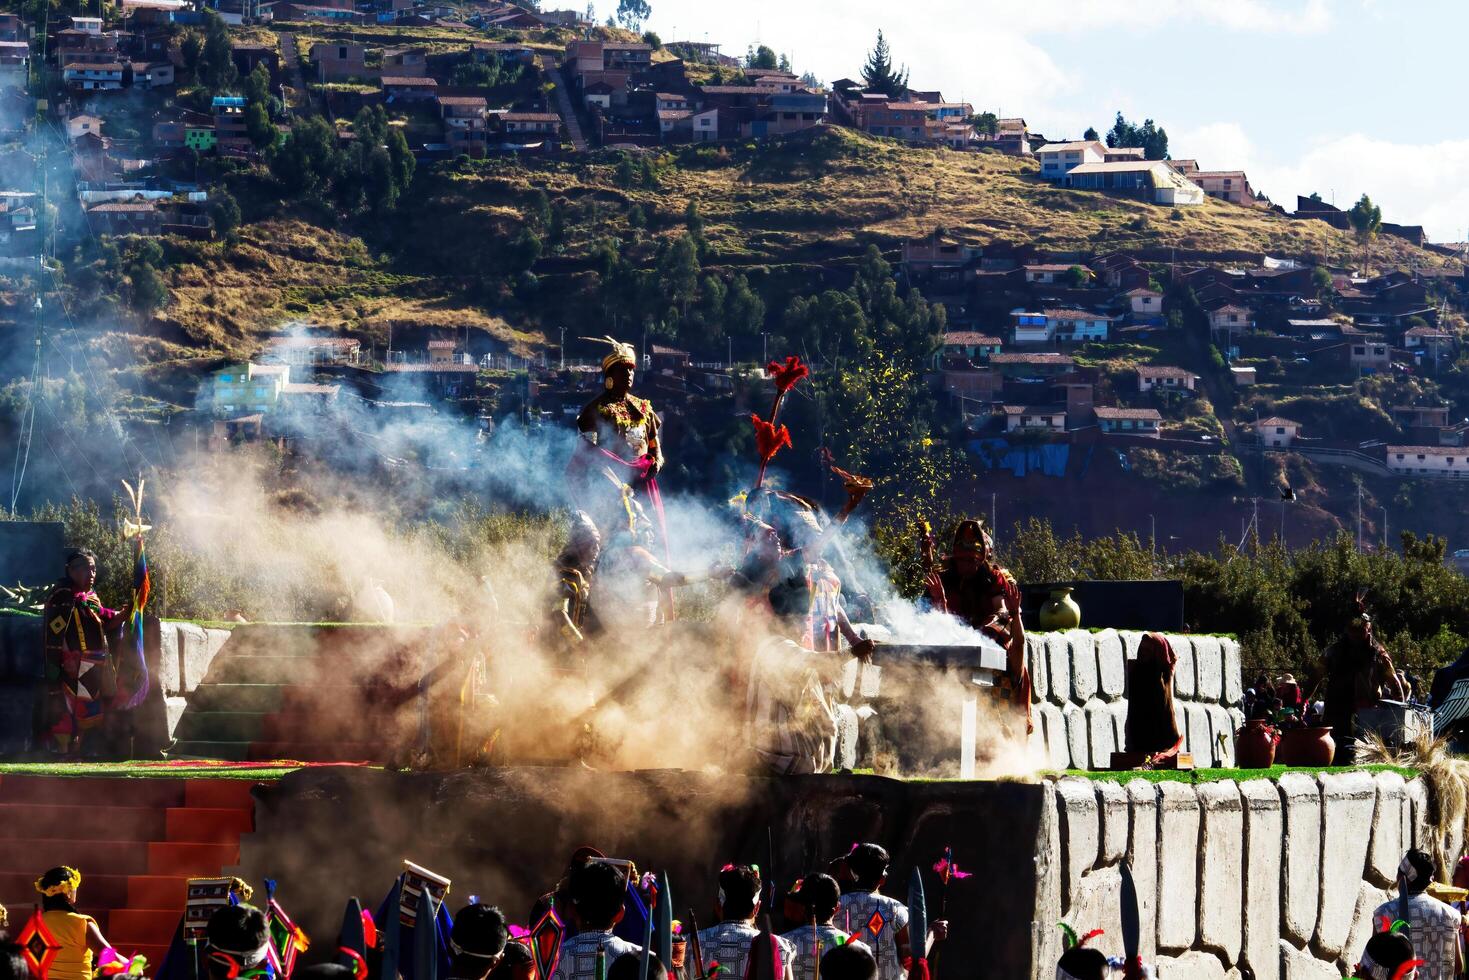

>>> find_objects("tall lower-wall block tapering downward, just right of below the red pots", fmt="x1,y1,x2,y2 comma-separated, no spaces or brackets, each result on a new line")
1313,773,1376,959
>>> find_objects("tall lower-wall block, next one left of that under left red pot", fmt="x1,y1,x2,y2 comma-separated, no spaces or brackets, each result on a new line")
1199,780,1244,964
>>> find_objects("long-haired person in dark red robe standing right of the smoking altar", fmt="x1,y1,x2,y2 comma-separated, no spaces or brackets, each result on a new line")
921,520,1034,733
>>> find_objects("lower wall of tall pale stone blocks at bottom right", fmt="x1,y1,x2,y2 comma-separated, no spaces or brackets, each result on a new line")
1033,771,1428,980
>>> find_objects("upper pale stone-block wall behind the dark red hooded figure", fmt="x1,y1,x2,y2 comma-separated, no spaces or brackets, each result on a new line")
1025,629,1244,770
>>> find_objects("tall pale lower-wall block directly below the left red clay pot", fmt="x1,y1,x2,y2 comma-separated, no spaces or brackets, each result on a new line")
1240,779,1282,980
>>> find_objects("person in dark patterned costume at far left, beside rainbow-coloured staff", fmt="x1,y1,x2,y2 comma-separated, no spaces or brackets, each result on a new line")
37,548,126,755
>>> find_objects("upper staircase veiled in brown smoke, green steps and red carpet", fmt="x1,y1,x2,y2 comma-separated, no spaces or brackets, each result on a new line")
169,626,429,763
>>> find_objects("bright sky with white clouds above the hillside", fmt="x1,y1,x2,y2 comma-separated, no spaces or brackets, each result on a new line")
637,0,1469,241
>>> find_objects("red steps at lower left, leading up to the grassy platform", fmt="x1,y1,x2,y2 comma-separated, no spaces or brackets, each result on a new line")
0,774,254,968
